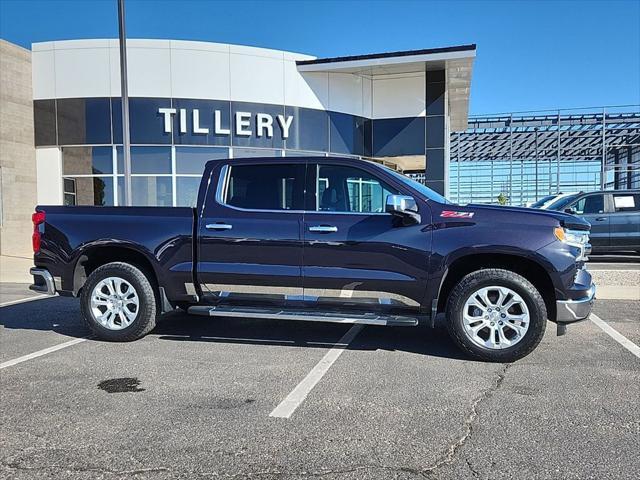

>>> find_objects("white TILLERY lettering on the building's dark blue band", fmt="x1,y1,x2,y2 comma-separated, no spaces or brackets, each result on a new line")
158,108,293,140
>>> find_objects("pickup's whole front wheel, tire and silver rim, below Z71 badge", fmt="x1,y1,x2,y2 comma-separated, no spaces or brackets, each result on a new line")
446,269,547,362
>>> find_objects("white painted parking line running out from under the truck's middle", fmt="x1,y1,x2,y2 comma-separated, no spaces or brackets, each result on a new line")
269,325,363,418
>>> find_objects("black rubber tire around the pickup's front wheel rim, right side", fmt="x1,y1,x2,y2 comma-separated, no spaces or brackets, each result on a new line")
446,268,547,362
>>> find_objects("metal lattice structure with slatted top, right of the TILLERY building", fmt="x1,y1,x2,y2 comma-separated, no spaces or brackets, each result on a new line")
448,106,640,205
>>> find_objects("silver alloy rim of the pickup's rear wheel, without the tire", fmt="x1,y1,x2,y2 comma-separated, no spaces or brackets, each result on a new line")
91,277,140,330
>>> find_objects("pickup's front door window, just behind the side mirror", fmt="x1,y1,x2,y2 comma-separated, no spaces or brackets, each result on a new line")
316,165,398,213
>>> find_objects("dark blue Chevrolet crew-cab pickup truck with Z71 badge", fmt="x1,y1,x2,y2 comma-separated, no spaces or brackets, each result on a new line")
31,157,595,362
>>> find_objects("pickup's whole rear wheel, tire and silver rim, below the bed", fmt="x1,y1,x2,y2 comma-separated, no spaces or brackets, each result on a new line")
80,262,157,342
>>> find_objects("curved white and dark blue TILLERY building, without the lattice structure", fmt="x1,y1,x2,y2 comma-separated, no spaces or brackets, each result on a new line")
1,39,476,253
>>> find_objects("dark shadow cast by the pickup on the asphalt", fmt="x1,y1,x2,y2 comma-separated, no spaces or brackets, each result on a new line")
0,297,468,359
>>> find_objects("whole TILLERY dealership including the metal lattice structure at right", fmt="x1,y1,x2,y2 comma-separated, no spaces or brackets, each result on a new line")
0,39,640,255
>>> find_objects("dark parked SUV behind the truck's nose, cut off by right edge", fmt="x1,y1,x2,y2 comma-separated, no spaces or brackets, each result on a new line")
547,190,640,253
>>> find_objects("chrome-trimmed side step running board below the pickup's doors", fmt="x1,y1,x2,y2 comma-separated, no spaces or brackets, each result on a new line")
187,305,418,327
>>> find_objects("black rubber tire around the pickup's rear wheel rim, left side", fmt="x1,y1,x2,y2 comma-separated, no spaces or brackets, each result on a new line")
80,262,159,342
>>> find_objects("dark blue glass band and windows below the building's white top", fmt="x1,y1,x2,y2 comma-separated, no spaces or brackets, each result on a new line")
34,95,445,206
